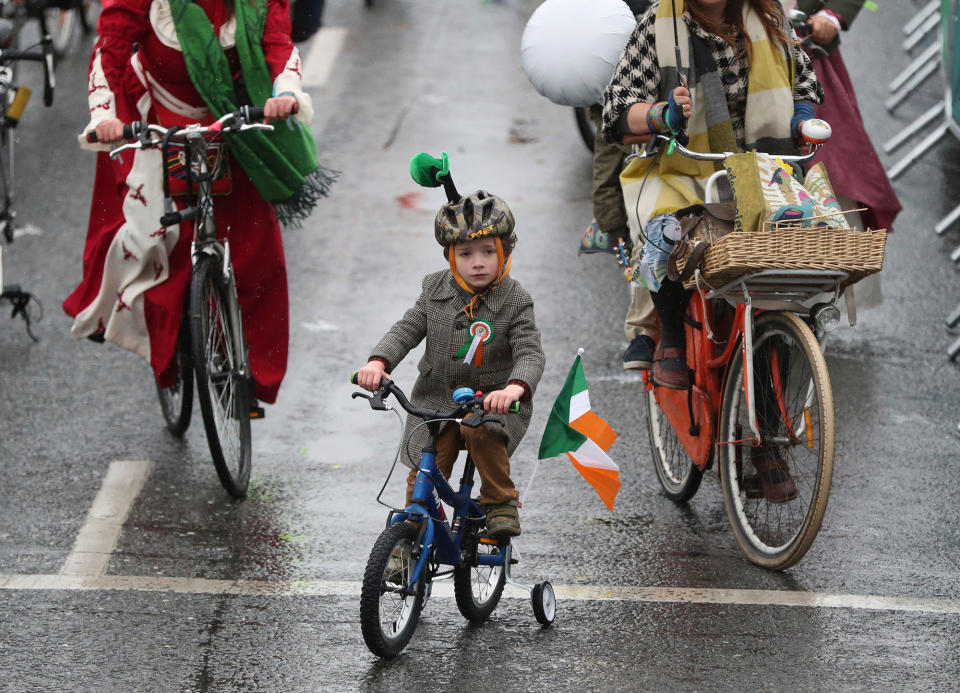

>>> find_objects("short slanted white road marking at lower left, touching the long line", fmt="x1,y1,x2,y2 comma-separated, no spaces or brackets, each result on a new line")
60,460,151,577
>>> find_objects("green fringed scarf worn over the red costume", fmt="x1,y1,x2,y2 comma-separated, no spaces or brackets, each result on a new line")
169,0,337,226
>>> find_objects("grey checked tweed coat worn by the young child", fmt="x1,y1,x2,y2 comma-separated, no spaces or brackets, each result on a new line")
371,269,545,467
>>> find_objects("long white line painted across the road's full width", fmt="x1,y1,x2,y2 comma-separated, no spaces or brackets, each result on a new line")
0,574,960,614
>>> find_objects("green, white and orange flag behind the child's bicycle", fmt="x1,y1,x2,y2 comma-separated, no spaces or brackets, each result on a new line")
538,350,620,512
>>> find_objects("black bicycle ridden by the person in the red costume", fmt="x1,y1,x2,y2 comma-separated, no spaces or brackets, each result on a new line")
88,106,273,498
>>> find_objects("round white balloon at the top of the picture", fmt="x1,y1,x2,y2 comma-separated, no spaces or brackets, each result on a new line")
520,0,637,106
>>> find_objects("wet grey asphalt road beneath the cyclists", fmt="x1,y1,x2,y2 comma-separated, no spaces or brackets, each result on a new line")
0,0,960,691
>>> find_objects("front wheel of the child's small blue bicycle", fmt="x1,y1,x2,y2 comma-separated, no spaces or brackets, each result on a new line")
360,522,425,657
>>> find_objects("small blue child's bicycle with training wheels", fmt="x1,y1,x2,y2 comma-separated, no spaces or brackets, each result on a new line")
352,374,557,657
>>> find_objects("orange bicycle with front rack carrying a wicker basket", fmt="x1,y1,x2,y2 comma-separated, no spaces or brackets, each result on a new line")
644,124,849,570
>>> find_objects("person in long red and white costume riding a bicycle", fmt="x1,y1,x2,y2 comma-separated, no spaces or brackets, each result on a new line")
63,0,313,403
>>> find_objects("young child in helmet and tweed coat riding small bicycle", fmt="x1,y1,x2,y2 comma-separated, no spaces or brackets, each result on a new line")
357,181,545,537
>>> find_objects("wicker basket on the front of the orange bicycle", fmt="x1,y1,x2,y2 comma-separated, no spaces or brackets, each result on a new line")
677,228,887,289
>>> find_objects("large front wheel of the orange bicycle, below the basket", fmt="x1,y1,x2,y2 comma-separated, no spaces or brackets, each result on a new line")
720,312,834,570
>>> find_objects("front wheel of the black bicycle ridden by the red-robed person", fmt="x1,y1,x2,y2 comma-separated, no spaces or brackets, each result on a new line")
190,256,250,498
